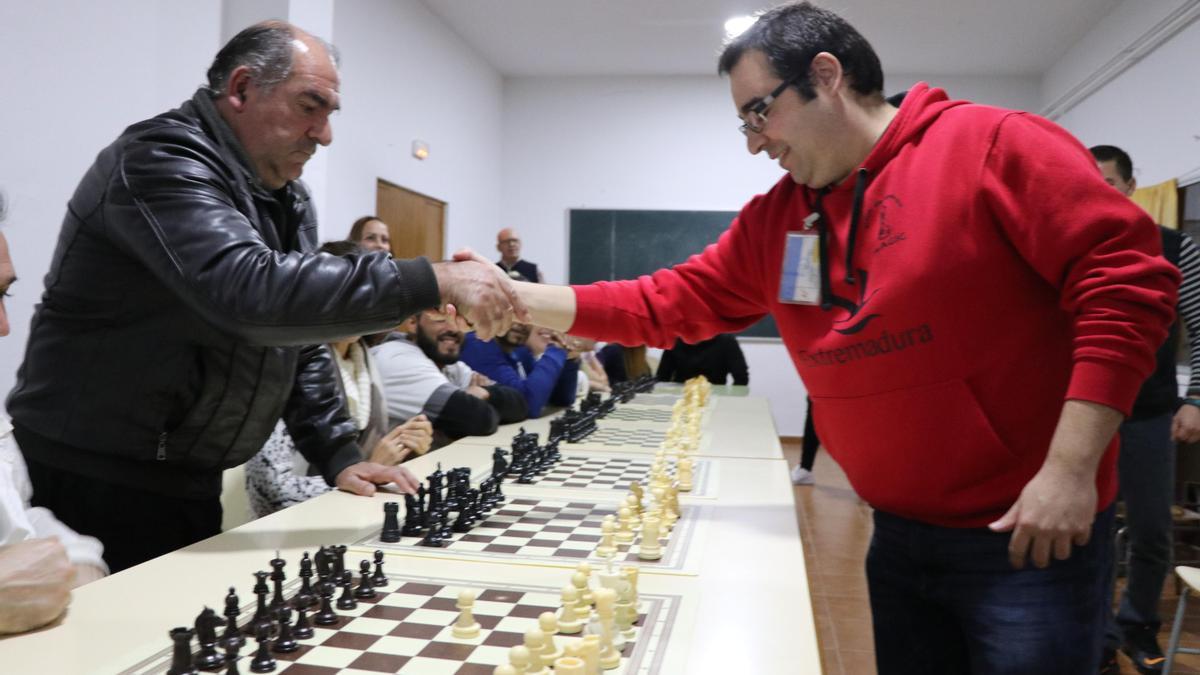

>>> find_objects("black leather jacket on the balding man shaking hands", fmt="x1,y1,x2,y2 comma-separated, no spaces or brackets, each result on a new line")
7,89,438,498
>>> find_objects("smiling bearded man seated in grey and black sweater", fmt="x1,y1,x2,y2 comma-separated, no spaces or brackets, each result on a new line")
371,311,528,447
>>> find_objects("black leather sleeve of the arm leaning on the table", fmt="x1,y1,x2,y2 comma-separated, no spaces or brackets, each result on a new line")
283,345,364,485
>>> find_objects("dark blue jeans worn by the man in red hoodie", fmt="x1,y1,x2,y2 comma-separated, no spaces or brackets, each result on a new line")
866,507,1112,675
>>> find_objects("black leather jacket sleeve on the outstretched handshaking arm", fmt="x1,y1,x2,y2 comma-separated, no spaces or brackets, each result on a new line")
109,127,438,346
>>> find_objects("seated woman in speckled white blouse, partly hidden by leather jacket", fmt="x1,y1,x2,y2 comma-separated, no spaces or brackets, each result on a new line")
246,241,433,516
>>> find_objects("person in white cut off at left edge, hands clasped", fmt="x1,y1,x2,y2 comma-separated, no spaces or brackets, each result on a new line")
0,201,108,634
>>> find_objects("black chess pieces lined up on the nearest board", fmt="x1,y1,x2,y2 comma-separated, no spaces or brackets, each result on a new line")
167,545,388,675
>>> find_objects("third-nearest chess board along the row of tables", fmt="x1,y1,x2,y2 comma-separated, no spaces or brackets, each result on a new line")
475,453,716,497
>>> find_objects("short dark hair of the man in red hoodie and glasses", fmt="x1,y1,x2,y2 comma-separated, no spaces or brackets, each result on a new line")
716,2,883,101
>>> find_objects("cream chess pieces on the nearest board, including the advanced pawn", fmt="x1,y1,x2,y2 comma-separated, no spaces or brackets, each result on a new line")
451,562,641,675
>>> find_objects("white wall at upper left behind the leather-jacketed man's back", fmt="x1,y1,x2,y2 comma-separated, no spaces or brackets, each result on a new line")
0,0,221,398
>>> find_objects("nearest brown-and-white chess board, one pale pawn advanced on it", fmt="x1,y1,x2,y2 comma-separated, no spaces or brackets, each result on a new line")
120,574,686,675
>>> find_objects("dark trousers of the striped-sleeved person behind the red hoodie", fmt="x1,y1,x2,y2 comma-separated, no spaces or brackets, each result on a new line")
1108,414,1175,649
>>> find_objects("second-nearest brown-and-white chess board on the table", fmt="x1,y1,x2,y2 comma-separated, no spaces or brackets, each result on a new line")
354,494,708,574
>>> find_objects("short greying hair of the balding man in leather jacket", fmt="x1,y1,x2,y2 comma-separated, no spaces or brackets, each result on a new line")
209,20,338,96
